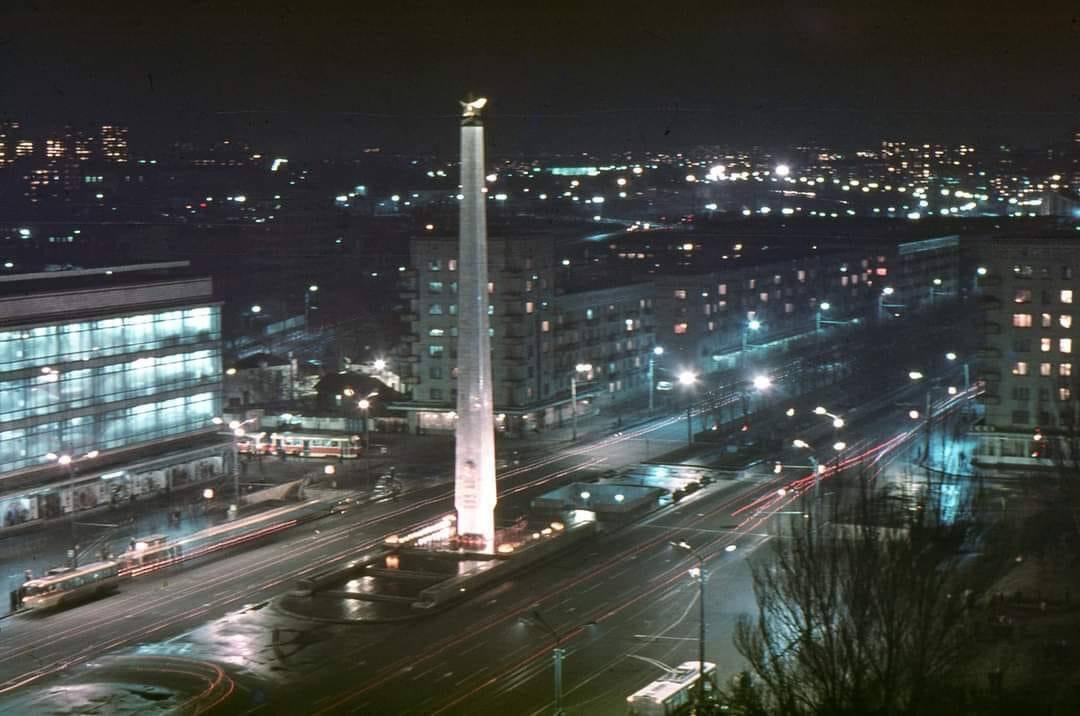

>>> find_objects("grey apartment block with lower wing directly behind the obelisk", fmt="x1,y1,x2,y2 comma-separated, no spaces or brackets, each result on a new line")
400,237,652,434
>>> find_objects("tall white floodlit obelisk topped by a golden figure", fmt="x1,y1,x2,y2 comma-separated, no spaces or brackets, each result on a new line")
454,98,496,552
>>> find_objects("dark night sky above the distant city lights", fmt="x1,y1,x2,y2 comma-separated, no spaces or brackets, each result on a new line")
0,0,1080,156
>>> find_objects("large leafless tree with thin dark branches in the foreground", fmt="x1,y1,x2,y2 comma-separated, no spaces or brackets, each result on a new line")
735,481,963,716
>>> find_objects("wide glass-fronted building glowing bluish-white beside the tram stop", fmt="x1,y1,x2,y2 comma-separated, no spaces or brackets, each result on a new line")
0,267,229,528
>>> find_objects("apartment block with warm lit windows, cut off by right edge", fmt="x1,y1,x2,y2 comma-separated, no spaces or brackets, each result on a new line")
973,237,1080,470
